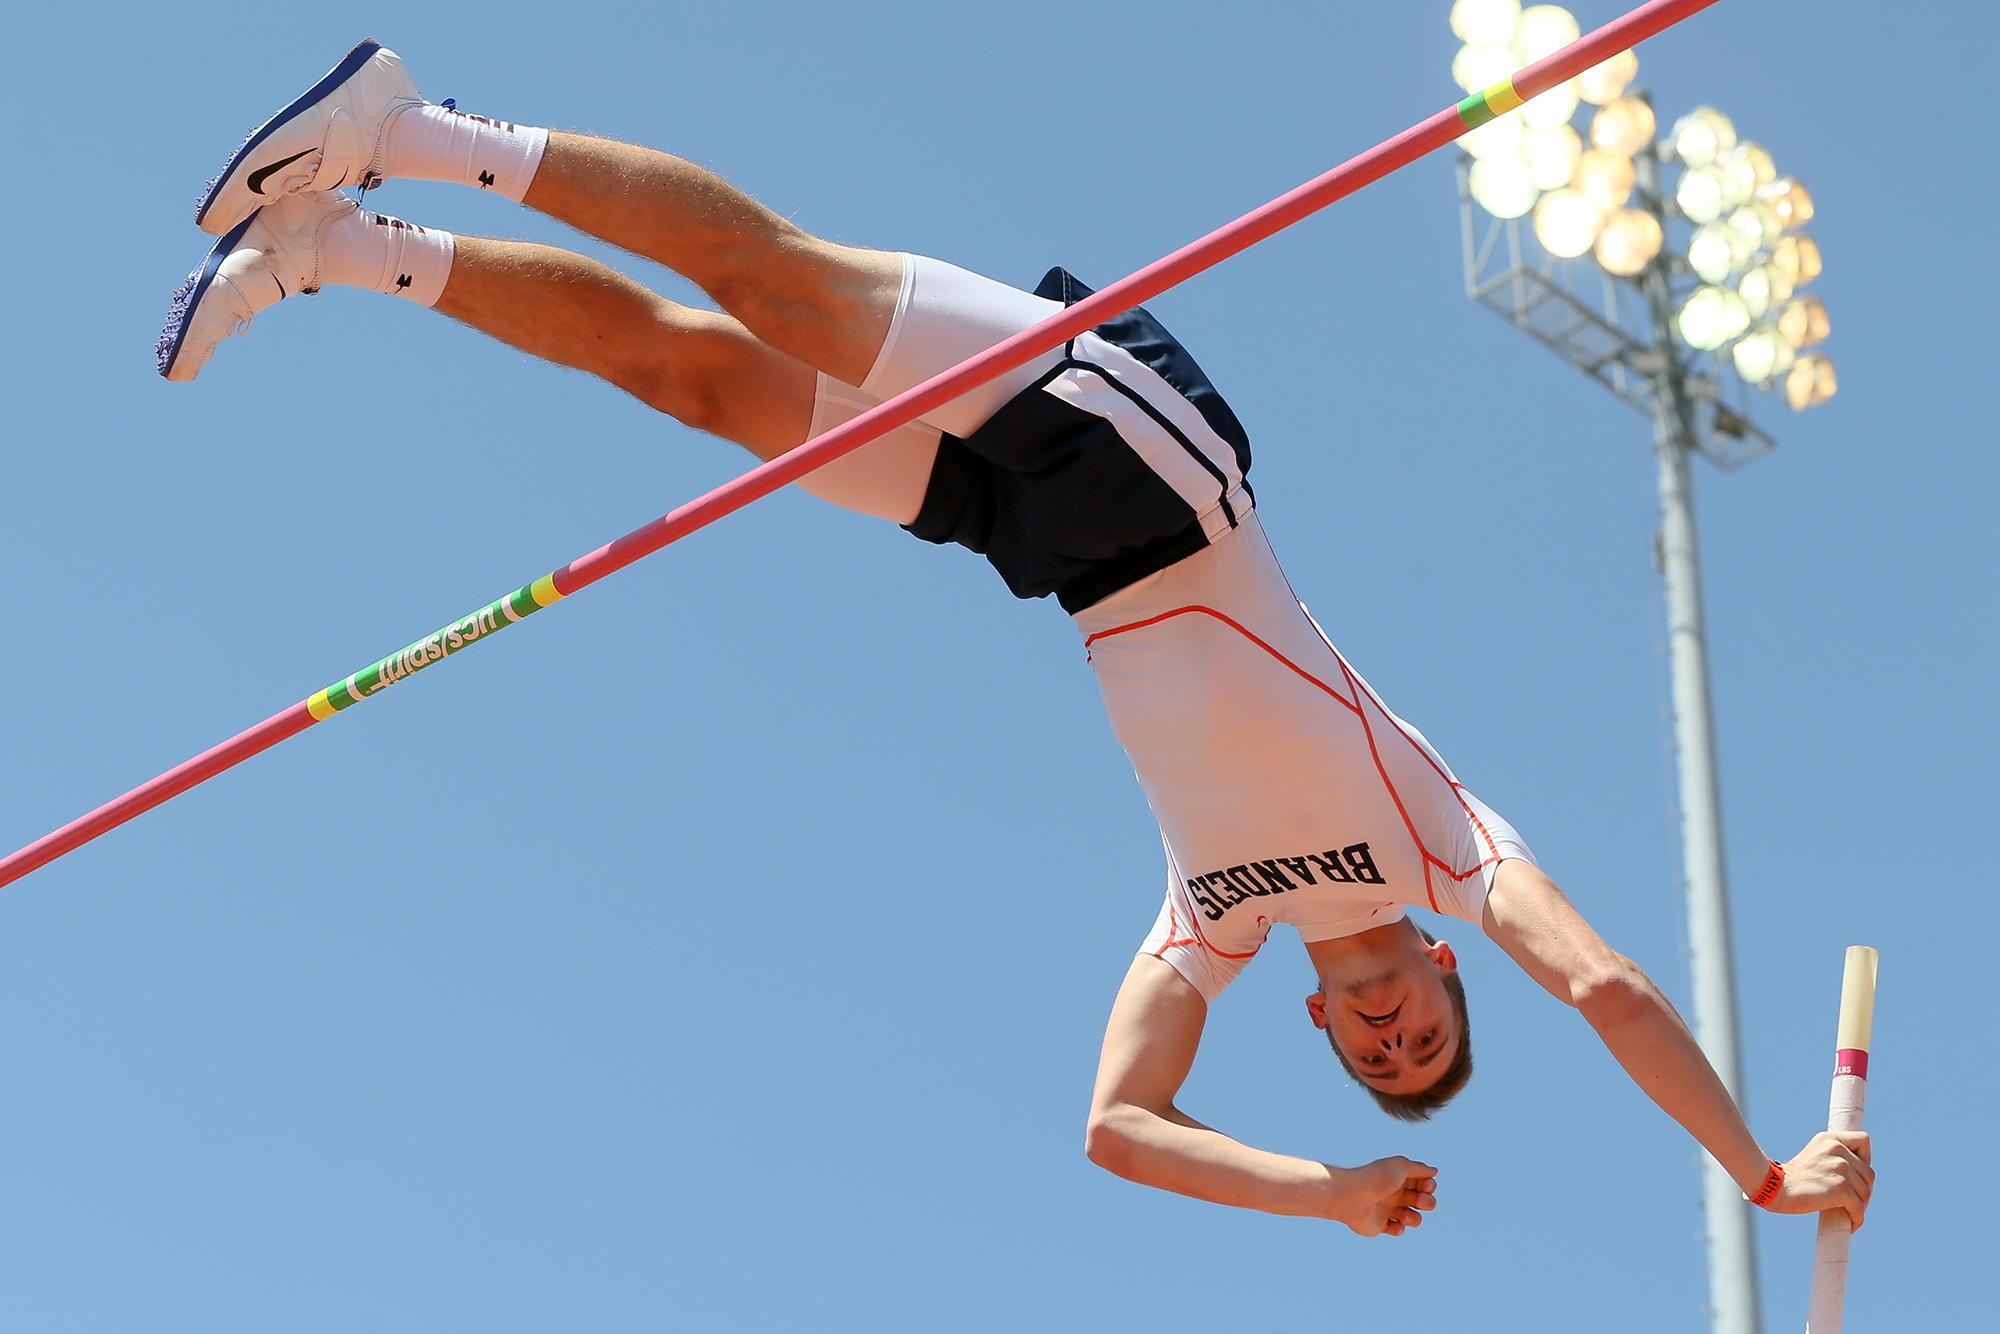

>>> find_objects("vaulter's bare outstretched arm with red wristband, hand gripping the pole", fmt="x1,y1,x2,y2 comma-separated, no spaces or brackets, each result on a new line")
1484,860,1874,1226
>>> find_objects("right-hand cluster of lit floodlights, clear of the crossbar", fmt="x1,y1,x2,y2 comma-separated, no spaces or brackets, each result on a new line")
1668,106,1840,408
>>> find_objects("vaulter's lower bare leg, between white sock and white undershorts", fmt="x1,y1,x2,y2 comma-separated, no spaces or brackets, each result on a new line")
436,236,812,458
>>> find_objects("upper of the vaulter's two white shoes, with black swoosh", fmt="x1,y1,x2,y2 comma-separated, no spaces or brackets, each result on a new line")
194,38,424,236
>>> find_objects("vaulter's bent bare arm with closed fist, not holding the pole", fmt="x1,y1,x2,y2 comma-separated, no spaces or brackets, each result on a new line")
1086,954,1438,1236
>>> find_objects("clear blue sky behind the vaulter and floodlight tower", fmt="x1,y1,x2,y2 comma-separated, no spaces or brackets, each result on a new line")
0,0,2000,1334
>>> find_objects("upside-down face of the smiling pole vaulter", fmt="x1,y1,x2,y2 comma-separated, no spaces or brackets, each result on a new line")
1306,942,1460,1094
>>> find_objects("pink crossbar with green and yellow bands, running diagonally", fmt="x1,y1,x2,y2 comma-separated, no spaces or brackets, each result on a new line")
0,0,1716,886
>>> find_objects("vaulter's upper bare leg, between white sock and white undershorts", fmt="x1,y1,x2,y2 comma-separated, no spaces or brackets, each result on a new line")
516,132,902,394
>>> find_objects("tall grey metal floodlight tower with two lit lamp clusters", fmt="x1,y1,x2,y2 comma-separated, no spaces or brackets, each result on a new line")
1452,0,1836,1334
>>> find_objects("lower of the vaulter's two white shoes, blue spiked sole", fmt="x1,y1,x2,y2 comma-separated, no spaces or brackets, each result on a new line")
158,190,360,382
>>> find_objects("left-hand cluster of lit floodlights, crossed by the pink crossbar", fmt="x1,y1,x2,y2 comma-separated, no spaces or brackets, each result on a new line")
1452,0,1666,278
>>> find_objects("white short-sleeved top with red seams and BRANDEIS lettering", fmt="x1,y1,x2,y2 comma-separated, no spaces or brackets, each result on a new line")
1074,512,1534,1000
